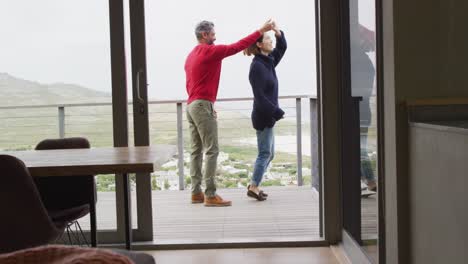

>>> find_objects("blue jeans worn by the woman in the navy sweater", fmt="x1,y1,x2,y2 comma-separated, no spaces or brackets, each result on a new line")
251,127,275,186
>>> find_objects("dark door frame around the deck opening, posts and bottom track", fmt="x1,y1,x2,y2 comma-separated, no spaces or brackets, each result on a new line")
105,0,366,248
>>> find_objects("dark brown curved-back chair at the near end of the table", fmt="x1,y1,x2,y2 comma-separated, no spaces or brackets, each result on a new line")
0,155,65,253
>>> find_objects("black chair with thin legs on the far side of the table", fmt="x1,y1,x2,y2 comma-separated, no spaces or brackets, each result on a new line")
34,137,97,247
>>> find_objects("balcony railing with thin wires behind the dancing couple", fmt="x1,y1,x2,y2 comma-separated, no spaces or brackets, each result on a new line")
0,95,320,190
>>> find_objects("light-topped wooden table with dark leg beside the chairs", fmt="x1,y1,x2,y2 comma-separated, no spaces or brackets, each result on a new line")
0,145,175,249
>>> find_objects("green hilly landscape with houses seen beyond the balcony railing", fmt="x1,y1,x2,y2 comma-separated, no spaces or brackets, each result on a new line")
0,73,318,191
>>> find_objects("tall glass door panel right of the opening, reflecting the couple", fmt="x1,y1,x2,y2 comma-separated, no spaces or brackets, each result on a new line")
342,0,379,263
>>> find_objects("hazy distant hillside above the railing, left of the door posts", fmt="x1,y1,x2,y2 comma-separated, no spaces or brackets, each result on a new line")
0,73,111,106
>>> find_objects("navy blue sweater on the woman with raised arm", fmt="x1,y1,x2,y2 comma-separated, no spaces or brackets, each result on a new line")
249,31,287,130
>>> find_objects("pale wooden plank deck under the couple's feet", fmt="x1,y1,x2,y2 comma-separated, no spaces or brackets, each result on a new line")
82,186,377,244
